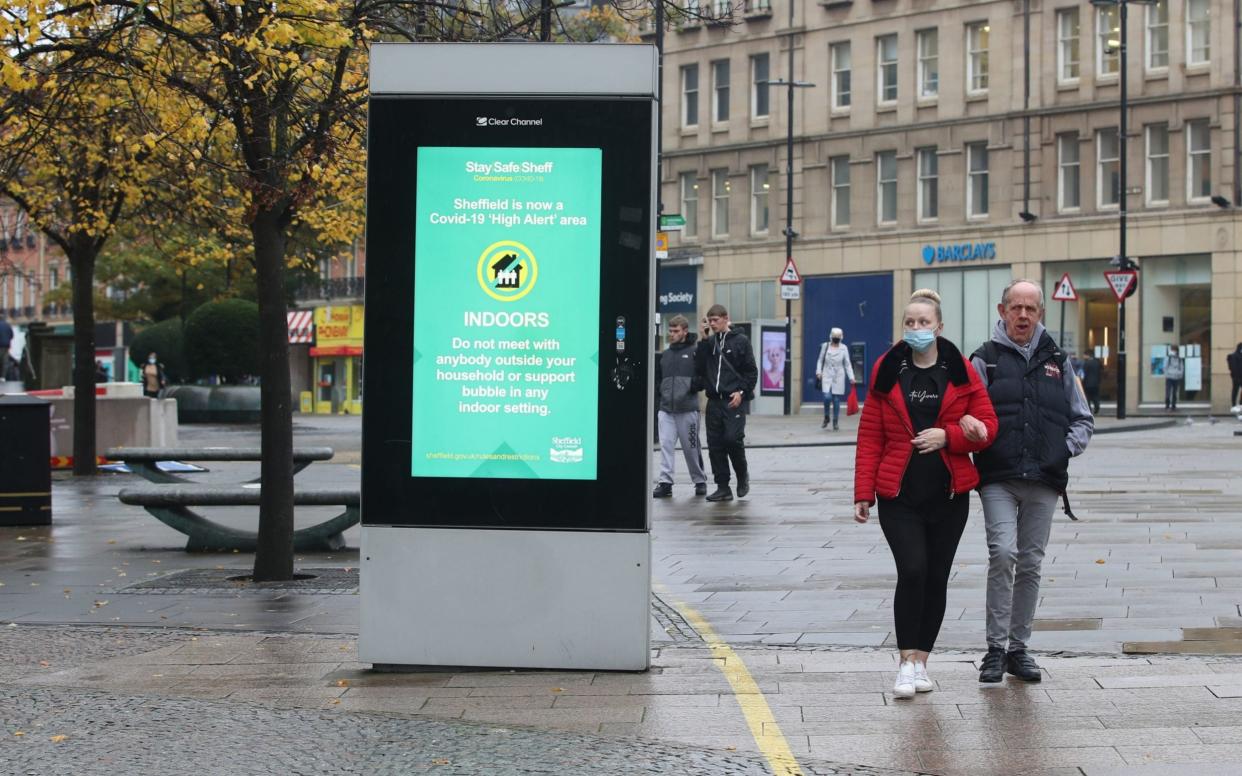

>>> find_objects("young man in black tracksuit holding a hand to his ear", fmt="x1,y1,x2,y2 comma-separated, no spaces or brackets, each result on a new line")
694,304,759,502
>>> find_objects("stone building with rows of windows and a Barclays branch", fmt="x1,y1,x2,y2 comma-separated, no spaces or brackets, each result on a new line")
645,0,1242,412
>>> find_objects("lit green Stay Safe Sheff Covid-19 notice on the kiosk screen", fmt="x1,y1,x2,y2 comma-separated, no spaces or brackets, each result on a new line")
410,142,602,479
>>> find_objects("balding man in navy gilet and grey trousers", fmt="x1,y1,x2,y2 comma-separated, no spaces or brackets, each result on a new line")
963,281,1095,683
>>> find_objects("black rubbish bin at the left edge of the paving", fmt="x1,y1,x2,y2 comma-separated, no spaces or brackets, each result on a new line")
0,395,52,525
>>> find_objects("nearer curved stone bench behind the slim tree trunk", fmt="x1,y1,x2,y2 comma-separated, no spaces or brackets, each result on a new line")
118,485,361,553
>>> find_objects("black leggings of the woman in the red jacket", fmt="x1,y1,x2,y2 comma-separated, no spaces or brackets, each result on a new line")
879,493,970,652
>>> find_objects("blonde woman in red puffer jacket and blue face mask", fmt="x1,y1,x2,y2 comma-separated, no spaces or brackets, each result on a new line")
854,289,996,698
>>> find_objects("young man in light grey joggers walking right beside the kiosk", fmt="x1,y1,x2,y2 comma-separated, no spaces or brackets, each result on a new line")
651,315,707,498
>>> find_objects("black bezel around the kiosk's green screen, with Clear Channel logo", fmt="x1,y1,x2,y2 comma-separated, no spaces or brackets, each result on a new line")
361,96,653,530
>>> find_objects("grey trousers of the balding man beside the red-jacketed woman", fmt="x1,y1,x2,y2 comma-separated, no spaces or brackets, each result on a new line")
979,479,1059,651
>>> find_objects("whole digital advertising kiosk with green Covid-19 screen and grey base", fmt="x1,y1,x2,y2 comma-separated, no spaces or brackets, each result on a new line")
358,42,657,670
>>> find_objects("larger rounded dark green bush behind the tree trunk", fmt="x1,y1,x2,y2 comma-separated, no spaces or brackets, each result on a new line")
185,299,258,382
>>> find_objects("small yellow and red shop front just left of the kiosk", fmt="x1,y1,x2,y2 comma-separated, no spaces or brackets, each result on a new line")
311,304,364,415
